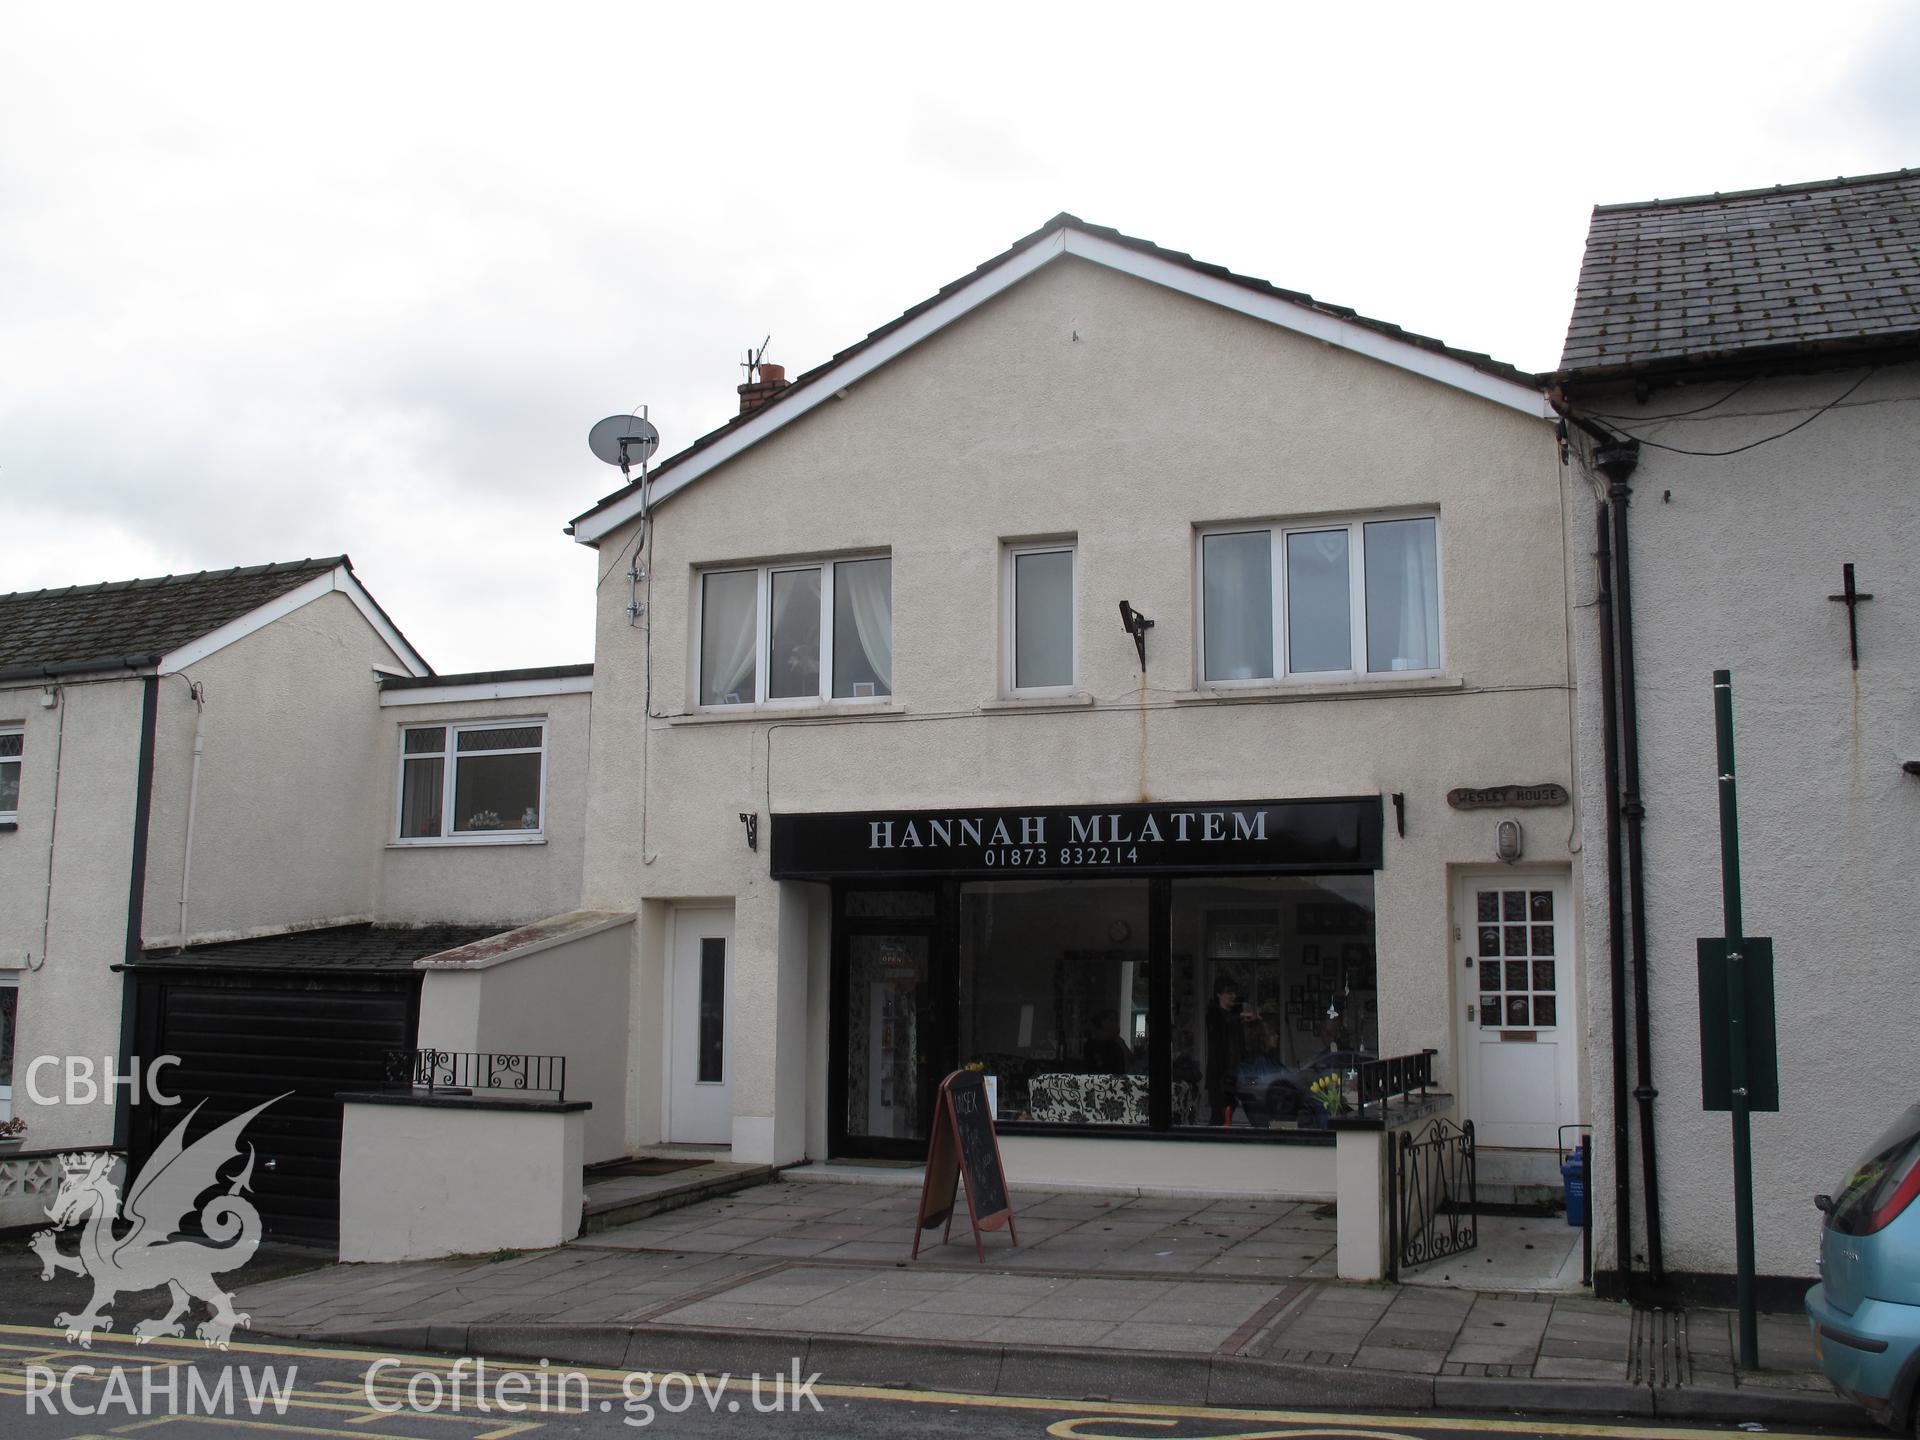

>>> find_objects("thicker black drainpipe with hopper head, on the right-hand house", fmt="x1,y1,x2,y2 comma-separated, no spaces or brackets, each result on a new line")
1594,440,1667,1286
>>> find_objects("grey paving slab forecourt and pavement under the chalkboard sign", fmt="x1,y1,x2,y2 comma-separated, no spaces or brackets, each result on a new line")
228,1183,1860,1425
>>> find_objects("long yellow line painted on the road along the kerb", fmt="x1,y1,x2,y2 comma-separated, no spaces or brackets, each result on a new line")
0,1325,1832,1440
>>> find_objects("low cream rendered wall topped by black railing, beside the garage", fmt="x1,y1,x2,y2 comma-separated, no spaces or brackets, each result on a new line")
340,1104,591,1263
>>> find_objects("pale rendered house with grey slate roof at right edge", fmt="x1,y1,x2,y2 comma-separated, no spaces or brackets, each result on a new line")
1551,171,1920,1298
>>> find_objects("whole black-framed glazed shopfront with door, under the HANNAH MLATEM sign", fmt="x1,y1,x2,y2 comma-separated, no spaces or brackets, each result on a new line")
829,874,1380,1156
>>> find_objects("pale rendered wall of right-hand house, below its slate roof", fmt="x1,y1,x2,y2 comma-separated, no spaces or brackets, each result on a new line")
1572,365,1920,1277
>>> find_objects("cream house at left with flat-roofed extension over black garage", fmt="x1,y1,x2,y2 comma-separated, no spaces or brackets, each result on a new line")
0,557,591,1240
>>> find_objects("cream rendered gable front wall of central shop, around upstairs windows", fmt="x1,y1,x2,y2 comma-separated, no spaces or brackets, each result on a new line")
584,259,1578,1194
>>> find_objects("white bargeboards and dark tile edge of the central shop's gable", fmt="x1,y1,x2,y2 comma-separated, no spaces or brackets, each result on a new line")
568,213,1551,545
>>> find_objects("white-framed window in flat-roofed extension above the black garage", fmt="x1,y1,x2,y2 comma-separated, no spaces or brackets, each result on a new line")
394,720,547,845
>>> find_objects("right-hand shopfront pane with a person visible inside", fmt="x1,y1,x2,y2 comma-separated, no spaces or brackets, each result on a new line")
1169,876,1380,1131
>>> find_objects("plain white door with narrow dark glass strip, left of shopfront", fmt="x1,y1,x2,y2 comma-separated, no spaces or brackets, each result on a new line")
666,910,733,1144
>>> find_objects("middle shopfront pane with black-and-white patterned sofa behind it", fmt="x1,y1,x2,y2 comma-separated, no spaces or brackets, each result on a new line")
958,879,1148,1125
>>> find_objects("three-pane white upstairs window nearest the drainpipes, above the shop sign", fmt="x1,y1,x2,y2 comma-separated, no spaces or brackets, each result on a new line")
1196,513,1442,687
